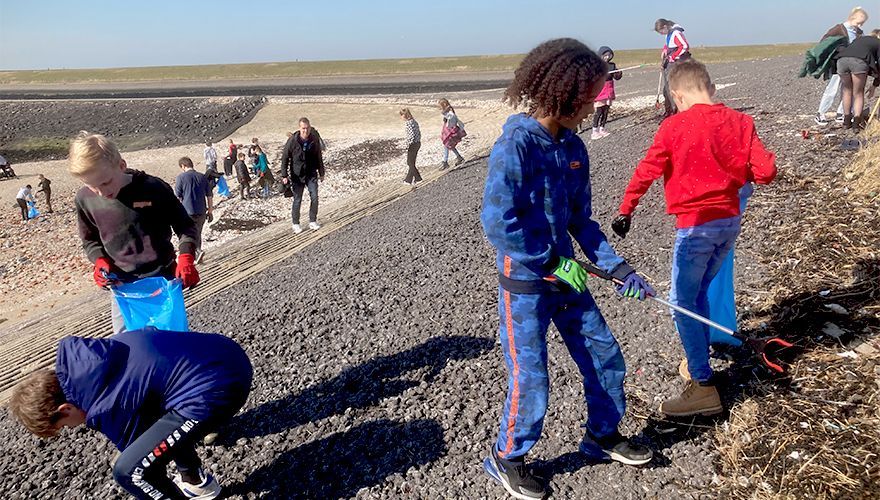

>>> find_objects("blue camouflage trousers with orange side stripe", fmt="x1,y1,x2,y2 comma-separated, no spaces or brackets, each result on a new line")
495,289,626,460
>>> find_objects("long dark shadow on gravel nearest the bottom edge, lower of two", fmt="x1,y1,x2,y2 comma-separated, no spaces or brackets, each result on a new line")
225,419,446,498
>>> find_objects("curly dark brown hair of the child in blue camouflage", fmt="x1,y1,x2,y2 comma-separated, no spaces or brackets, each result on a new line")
502,38,608,116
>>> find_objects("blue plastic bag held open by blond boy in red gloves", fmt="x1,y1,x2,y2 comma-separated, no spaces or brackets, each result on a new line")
112,276,189,332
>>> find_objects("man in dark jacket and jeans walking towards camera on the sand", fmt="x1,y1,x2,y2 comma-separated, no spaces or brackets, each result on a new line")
281,117,324,234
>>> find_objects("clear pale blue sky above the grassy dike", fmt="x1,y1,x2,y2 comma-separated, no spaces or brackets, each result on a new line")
0,0,868,69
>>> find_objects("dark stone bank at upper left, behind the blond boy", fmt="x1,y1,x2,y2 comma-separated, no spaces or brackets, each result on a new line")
0,97,265,162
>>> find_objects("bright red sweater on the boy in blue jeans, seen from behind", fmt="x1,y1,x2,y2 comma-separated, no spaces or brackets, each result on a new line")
620,104,776,228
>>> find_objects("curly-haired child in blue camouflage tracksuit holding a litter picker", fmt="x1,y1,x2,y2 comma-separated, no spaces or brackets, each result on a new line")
481,39,653,498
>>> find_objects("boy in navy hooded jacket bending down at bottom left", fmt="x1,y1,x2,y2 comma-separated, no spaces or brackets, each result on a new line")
9,328,253,500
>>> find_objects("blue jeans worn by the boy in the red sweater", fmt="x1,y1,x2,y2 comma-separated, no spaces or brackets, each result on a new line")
669,216,741,382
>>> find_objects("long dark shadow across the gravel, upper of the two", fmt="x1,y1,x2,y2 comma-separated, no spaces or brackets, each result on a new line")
221,336,495,445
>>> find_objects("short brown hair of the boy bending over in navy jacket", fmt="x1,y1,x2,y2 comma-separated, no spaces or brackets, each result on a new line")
9,369,67,438
